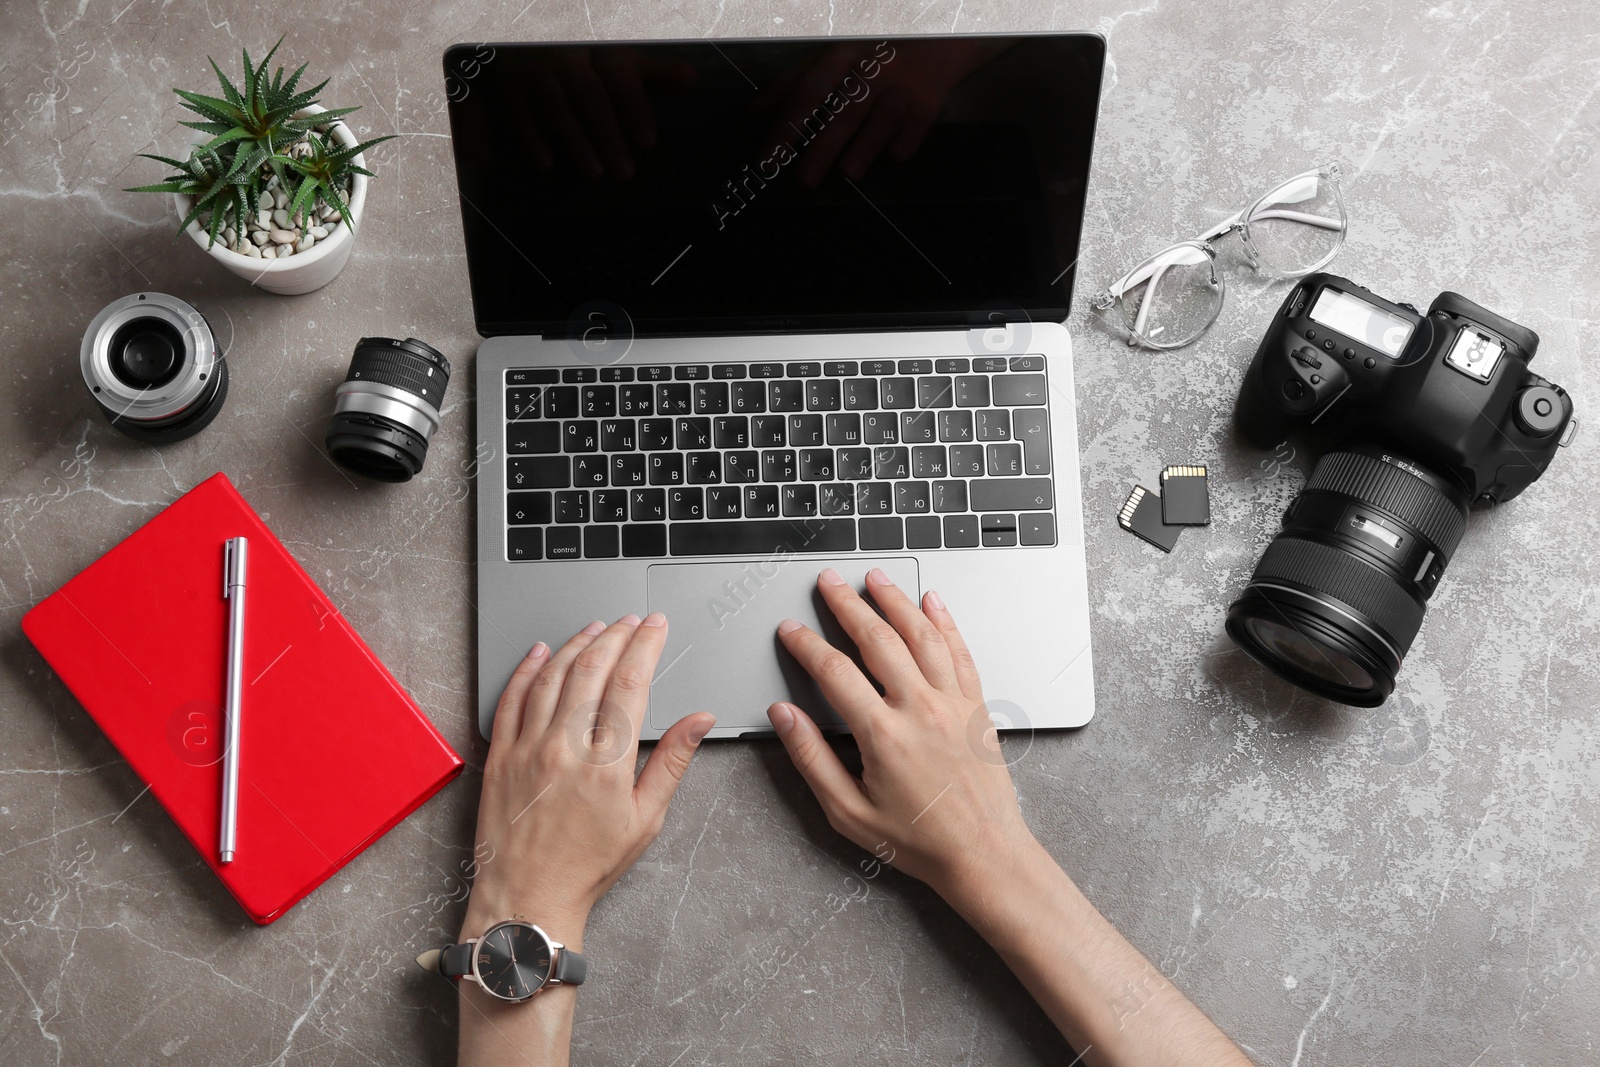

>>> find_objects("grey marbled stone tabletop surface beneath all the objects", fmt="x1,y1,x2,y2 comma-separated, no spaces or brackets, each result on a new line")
0,0,1600,1067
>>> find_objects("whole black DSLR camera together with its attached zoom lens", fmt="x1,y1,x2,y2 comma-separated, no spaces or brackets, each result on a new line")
1227,274,1578,707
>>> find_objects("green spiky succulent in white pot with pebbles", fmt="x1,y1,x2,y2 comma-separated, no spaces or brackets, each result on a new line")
126,37,390,294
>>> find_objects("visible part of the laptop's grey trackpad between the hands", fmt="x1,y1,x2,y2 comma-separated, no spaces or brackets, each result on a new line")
646,555,922,731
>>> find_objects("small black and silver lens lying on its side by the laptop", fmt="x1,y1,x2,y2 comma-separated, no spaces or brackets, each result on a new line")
326,338,450,482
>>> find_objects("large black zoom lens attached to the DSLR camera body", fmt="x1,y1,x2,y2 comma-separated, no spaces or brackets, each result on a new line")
1227,445,1467,707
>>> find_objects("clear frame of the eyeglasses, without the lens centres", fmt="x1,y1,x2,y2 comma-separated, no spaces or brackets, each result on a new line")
1091,163,1349,350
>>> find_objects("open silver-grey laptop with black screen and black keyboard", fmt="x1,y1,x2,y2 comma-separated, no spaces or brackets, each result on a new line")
445,34,1106,739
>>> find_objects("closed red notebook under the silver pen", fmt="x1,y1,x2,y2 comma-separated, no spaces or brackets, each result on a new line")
22,474,462,923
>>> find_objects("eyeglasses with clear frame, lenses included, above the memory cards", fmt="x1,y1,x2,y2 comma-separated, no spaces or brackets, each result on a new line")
1091,163,1349,349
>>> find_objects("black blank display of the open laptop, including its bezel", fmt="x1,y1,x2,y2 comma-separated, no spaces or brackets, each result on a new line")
445,34,1106,336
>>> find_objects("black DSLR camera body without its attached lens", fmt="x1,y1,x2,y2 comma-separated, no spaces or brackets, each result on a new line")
1235,274,1576,509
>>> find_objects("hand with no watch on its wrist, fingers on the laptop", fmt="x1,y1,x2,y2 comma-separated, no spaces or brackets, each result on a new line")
766,568,1040,899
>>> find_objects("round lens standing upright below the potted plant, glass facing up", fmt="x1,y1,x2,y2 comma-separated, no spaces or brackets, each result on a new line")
78,293,227,445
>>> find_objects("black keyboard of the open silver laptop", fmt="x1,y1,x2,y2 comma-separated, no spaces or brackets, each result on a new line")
506,355,1056,561
